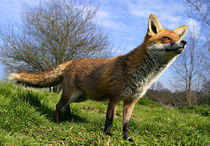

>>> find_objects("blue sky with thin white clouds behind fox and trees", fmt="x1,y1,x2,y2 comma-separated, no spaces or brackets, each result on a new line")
0,0,201,87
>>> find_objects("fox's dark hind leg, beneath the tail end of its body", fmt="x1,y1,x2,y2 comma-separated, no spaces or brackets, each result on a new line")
56,90,82,122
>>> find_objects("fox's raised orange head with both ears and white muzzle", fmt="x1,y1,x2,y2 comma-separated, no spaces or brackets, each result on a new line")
144,14,188,58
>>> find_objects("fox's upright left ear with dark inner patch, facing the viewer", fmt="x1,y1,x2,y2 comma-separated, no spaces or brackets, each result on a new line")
148,14,163,36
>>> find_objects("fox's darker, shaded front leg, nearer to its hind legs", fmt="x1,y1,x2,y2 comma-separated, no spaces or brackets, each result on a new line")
104,100,119,136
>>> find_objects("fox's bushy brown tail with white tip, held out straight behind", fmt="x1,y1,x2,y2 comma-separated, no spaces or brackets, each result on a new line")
8,61,71,87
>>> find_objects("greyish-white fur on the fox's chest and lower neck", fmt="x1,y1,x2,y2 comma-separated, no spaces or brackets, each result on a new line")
122,54,175,100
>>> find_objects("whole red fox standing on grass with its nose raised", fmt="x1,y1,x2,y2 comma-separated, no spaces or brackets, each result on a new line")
8,14,188,141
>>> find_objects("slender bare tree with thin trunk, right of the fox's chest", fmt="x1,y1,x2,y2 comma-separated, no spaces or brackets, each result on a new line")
170,29,209,105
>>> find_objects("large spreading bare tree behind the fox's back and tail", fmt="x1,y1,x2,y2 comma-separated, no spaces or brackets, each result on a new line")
0,0,110,73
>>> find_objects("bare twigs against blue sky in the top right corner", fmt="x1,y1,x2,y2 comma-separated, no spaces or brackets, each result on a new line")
185,0,210,25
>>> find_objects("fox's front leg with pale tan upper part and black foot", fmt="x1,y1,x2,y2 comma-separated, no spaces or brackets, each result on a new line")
123,101,135,141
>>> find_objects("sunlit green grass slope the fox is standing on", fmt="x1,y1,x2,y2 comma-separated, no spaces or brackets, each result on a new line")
0,82,210,146
